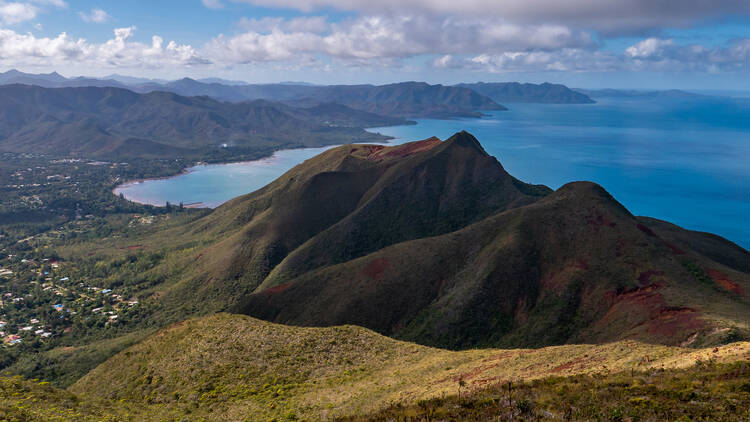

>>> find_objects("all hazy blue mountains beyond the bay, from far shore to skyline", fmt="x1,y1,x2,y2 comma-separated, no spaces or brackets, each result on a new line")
0,70,604,161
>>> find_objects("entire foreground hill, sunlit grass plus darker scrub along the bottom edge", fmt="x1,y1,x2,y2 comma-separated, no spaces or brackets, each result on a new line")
0,314,750,421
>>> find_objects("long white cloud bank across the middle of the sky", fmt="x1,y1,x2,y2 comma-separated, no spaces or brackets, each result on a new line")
210,16,595,63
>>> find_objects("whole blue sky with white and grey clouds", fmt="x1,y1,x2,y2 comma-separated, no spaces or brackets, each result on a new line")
0,0,750,91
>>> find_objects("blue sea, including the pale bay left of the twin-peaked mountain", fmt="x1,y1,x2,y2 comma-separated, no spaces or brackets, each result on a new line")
118,96,750,248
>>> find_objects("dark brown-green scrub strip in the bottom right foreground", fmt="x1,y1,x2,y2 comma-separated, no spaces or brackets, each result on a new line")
340,361,750,422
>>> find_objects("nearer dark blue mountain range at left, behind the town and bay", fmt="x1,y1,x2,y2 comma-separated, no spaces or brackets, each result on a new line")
0,85,408,159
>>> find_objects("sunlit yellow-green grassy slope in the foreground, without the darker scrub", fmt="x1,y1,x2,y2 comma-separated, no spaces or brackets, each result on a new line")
70,314,750,420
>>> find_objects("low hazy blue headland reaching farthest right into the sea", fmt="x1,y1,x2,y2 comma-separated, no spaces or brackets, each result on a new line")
456,82,595,104
